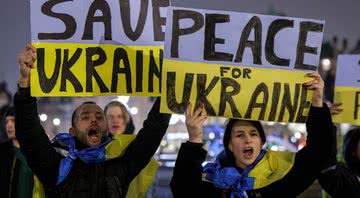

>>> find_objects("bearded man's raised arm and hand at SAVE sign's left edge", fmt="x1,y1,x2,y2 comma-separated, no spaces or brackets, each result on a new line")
14,45,61,186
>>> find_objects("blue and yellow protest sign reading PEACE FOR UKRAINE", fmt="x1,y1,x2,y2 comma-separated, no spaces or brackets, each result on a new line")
161,7,324,122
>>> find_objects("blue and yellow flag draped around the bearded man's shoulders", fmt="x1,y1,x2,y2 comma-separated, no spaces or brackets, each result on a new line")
33,133,159,198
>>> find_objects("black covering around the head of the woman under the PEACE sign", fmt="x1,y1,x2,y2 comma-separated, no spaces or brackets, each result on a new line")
223,118,266,162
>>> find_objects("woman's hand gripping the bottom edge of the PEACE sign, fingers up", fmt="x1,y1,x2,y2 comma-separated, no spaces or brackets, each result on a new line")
185,103,208,143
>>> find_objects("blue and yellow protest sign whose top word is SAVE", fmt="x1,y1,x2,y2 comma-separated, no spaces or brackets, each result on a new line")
31,0,169,96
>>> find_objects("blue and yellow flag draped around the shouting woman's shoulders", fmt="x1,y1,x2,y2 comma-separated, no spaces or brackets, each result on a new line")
203,150,295,198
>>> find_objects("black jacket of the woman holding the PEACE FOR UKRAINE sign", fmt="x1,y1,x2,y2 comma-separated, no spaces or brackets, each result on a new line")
170,105,332,198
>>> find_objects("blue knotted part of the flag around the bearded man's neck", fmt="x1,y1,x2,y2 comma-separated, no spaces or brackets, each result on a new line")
53,133,111,185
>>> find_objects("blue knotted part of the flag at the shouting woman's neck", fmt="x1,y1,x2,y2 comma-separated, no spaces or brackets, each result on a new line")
203,149,266,198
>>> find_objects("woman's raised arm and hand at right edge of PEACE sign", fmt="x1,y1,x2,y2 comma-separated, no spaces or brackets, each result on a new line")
260,72,333,197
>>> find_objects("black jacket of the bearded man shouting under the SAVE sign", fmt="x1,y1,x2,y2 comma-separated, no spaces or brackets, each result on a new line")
14,88,170,198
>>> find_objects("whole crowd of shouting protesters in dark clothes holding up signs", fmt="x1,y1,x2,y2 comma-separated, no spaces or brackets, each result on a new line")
0,37,360,198
